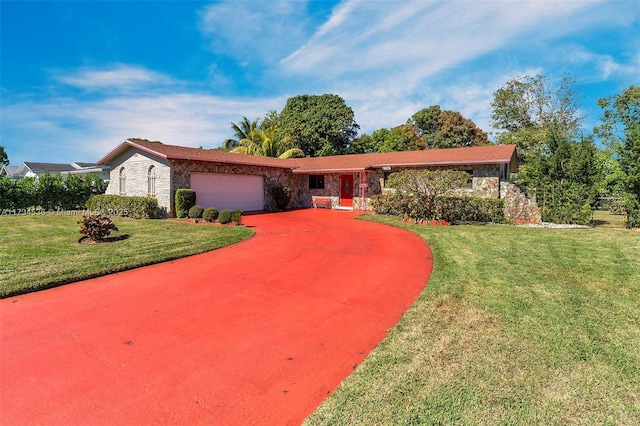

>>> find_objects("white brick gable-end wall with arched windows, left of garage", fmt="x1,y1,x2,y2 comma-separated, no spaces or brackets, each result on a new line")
105,148,173,216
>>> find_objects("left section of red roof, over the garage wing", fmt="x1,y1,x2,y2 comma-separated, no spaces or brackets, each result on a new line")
98,139,295,169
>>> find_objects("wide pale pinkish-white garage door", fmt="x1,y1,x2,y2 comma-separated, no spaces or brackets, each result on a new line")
191,173,264,211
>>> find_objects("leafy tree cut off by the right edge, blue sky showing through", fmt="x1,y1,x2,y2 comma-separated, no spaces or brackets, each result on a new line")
594,85,640,199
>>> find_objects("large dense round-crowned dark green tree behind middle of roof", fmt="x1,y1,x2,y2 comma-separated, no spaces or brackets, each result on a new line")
279,94,360,157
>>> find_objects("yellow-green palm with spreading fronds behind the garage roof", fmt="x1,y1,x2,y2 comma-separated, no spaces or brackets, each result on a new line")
231,126,304,158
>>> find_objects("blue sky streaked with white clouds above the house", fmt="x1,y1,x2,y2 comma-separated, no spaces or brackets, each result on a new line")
0,0,640,165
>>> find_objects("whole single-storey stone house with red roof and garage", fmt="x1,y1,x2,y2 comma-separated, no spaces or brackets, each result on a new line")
98,140,539,220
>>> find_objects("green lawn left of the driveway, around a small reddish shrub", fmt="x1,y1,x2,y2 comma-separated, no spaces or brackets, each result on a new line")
0,214,253,297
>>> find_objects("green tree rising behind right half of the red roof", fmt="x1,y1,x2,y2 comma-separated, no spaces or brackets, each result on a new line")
407,105,489,149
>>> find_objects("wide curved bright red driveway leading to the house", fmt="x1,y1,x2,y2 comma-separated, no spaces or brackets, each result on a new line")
0,209,431,425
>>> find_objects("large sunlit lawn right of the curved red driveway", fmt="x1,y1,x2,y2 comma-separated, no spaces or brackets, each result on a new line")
305,216,640,425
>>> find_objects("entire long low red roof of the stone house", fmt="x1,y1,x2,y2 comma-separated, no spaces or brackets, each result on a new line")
98,140,517,174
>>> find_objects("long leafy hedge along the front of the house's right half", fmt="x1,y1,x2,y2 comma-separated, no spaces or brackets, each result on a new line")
371,191,504,223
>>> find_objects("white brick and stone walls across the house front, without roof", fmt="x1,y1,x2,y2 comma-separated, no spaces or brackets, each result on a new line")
107,148,540,221
